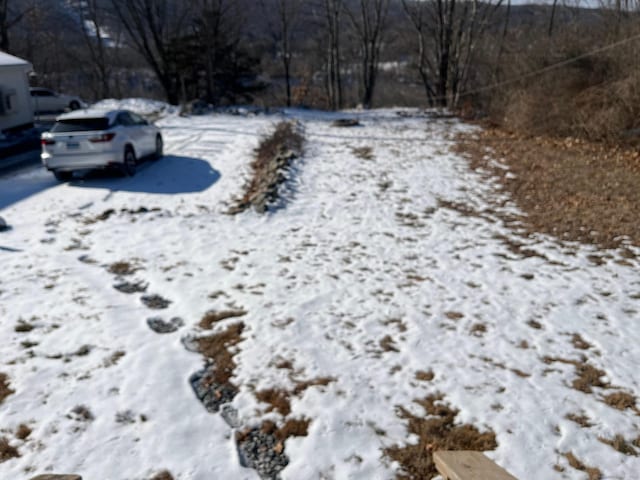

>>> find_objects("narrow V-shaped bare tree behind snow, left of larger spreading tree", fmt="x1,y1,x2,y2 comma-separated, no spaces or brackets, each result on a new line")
344,0,389,108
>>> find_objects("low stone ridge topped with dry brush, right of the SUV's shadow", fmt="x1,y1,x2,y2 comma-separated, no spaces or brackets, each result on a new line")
228,122,304,215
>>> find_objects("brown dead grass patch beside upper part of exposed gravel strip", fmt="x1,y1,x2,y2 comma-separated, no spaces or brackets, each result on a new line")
197,322,245,385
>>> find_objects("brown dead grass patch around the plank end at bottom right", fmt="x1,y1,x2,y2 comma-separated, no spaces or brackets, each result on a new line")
384,394,498,479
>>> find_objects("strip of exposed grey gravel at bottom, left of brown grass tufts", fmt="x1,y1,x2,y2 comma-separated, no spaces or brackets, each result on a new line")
182,336,289,480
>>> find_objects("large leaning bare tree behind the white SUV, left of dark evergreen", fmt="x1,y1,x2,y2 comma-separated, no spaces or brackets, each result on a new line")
111,0,192,104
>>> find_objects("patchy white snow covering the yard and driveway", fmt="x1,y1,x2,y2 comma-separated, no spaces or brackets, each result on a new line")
0,106,640,480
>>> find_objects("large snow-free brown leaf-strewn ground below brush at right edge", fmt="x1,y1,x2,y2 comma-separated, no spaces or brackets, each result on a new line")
458,129,640,248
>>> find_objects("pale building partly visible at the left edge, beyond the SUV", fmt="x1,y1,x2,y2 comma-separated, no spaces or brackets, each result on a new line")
0,52,33,133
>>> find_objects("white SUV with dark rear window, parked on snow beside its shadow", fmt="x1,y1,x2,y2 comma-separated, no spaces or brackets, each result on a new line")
41,110,163,181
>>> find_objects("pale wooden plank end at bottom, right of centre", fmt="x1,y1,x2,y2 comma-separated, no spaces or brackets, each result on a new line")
433,450,517,480
